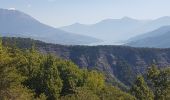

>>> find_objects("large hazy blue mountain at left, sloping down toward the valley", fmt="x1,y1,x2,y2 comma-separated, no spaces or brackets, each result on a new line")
0,9,100,44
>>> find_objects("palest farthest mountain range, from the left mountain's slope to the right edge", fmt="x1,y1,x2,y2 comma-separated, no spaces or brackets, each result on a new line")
60,16,170,44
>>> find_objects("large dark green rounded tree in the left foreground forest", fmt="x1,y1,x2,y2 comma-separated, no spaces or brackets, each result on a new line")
25,55,63,100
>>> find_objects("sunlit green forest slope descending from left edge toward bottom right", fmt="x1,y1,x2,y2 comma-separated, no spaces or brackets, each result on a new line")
0,38,135,100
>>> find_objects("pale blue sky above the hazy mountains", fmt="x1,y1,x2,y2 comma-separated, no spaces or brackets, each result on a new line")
0,0,170,27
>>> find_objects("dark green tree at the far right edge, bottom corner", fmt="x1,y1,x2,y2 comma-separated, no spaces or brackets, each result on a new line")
147,65,170,100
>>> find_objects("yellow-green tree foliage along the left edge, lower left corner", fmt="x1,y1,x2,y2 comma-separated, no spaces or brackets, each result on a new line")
0,45,33,100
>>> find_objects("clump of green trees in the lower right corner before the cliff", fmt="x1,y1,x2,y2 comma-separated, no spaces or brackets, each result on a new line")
130,65,170,100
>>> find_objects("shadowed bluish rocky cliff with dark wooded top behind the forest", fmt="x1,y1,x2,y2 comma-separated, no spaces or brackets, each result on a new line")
4,38,170,86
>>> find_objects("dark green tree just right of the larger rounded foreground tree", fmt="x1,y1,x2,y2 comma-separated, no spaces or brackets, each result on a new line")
58,60,82,95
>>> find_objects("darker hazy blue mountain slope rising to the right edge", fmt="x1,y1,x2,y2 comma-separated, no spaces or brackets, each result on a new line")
126,26,170,48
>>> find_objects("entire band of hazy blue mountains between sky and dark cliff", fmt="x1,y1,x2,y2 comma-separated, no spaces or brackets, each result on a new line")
0,9,170,48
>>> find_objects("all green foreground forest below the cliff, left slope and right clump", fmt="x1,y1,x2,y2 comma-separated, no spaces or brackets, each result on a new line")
0,37,170,100
